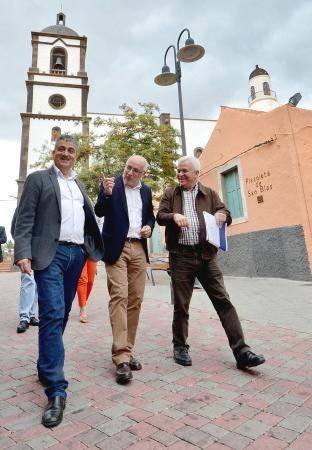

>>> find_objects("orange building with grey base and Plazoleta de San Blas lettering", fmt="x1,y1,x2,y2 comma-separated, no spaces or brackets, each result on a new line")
201,105,312,280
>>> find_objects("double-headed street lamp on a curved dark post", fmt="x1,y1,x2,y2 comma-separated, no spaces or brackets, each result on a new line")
154,28,205,155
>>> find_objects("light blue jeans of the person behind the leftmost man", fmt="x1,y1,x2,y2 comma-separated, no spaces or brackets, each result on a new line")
19,272,38,323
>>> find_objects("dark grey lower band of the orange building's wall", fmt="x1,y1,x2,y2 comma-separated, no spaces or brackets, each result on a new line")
219,225,312,281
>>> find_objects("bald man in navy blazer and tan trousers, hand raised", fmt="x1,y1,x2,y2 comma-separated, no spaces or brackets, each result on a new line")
94,155,155,384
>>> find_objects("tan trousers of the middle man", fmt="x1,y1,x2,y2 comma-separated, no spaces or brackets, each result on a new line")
105,241,146,365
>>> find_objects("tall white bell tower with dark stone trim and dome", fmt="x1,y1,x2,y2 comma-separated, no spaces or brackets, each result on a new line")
17,12,89,199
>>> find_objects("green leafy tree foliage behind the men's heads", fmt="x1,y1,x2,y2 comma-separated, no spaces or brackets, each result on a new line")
35,103,179,200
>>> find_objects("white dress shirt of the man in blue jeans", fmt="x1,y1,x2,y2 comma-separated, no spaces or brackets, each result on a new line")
54,166,85,244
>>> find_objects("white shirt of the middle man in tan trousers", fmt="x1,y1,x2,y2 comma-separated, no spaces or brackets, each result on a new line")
125,178,142,239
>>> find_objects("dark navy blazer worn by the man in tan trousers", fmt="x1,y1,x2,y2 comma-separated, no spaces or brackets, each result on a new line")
94,176,155,264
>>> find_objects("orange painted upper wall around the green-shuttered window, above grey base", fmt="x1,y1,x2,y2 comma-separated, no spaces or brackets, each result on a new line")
201,106,312,267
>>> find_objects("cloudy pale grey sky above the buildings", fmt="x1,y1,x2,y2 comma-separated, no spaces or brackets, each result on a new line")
0,0,312,236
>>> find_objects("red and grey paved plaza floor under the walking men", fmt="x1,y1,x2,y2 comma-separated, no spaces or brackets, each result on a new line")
0,265,312,450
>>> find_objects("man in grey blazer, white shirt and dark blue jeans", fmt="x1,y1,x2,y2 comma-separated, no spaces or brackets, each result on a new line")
14,135,103,427
